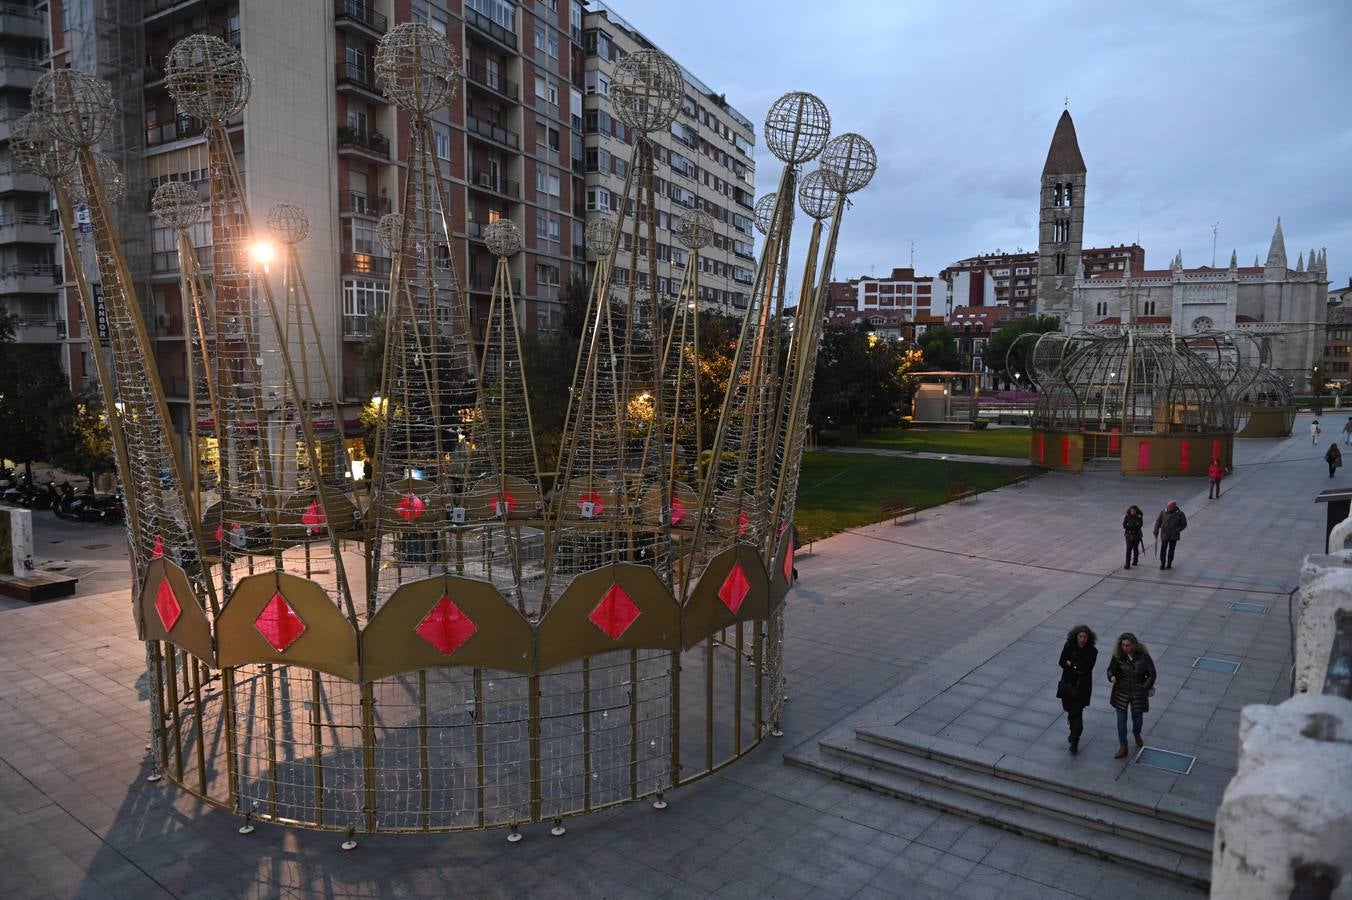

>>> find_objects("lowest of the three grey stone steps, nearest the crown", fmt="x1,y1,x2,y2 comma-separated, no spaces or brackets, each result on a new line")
786,742,1211,888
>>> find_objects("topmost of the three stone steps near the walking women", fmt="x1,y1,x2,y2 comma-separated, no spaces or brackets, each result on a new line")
854,726,1215,832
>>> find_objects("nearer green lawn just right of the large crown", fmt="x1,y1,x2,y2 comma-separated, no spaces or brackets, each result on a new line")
795,448,1026,538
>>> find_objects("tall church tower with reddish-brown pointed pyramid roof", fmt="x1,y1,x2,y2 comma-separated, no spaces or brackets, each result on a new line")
1037,109,1088,322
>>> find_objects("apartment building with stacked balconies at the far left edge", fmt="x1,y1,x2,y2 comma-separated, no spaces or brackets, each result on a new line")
0,0,65,351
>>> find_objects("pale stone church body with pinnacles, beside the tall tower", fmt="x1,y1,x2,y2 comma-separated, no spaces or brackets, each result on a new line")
1063,219,1328,391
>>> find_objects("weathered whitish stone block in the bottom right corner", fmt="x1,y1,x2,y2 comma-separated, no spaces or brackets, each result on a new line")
1211,693,1352,900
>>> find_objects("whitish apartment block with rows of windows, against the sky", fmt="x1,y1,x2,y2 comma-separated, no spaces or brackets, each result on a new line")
577,0,756,315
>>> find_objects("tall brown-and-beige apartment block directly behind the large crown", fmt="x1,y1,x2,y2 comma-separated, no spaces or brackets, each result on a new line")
39,0,585,456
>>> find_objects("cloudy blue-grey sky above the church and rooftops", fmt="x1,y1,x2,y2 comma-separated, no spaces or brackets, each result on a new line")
611,0,1352,301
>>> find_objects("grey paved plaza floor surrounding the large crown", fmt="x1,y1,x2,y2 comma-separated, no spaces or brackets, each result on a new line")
0,418,1330,900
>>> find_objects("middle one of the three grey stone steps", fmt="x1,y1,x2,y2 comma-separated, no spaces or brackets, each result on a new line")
822,741,1211,865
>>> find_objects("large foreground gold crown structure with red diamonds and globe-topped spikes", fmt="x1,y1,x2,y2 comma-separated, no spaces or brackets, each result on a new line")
23,31,877,846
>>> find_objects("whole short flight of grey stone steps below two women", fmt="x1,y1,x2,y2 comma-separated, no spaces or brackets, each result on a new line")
786,726,1214,888
